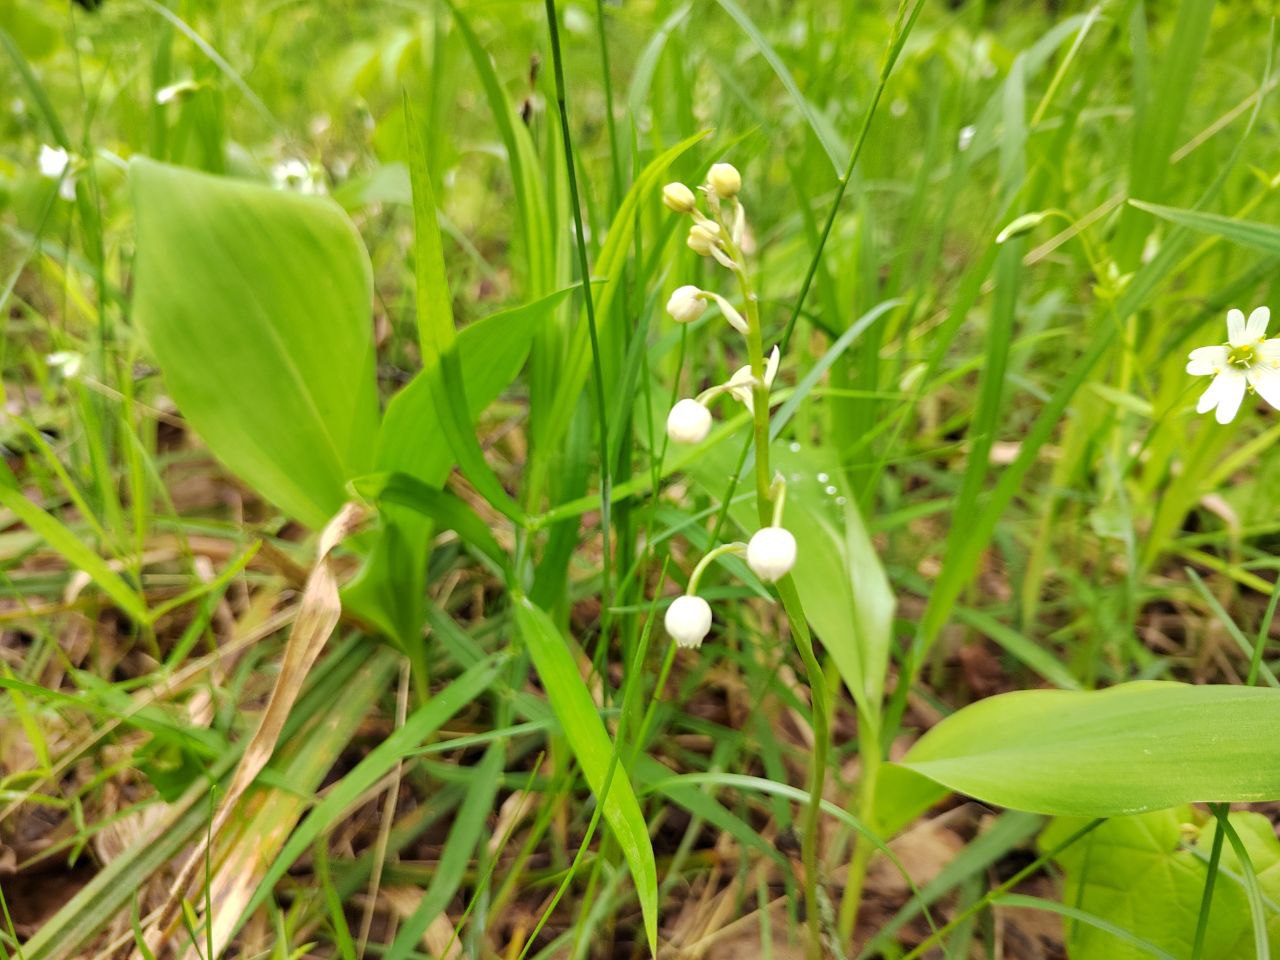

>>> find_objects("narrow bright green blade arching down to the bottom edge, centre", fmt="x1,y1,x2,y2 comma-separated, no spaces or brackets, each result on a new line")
515,598,658,954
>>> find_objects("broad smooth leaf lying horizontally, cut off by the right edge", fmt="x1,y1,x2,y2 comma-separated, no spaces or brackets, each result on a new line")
902,682,1280,817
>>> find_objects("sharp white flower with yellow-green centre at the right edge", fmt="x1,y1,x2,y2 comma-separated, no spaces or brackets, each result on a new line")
1187,307,1280,424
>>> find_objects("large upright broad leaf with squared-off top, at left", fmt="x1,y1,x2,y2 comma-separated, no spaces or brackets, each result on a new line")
129,157,378,527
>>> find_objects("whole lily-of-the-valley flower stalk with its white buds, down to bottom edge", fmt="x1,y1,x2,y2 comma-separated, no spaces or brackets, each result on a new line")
662,163,829,957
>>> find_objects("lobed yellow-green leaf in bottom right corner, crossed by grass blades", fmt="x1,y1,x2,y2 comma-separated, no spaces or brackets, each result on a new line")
1039,806,1280,960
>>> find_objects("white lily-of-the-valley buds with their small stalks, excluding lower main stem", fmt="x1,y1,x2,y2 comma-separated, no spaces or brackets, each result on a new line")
662,163,796,649
